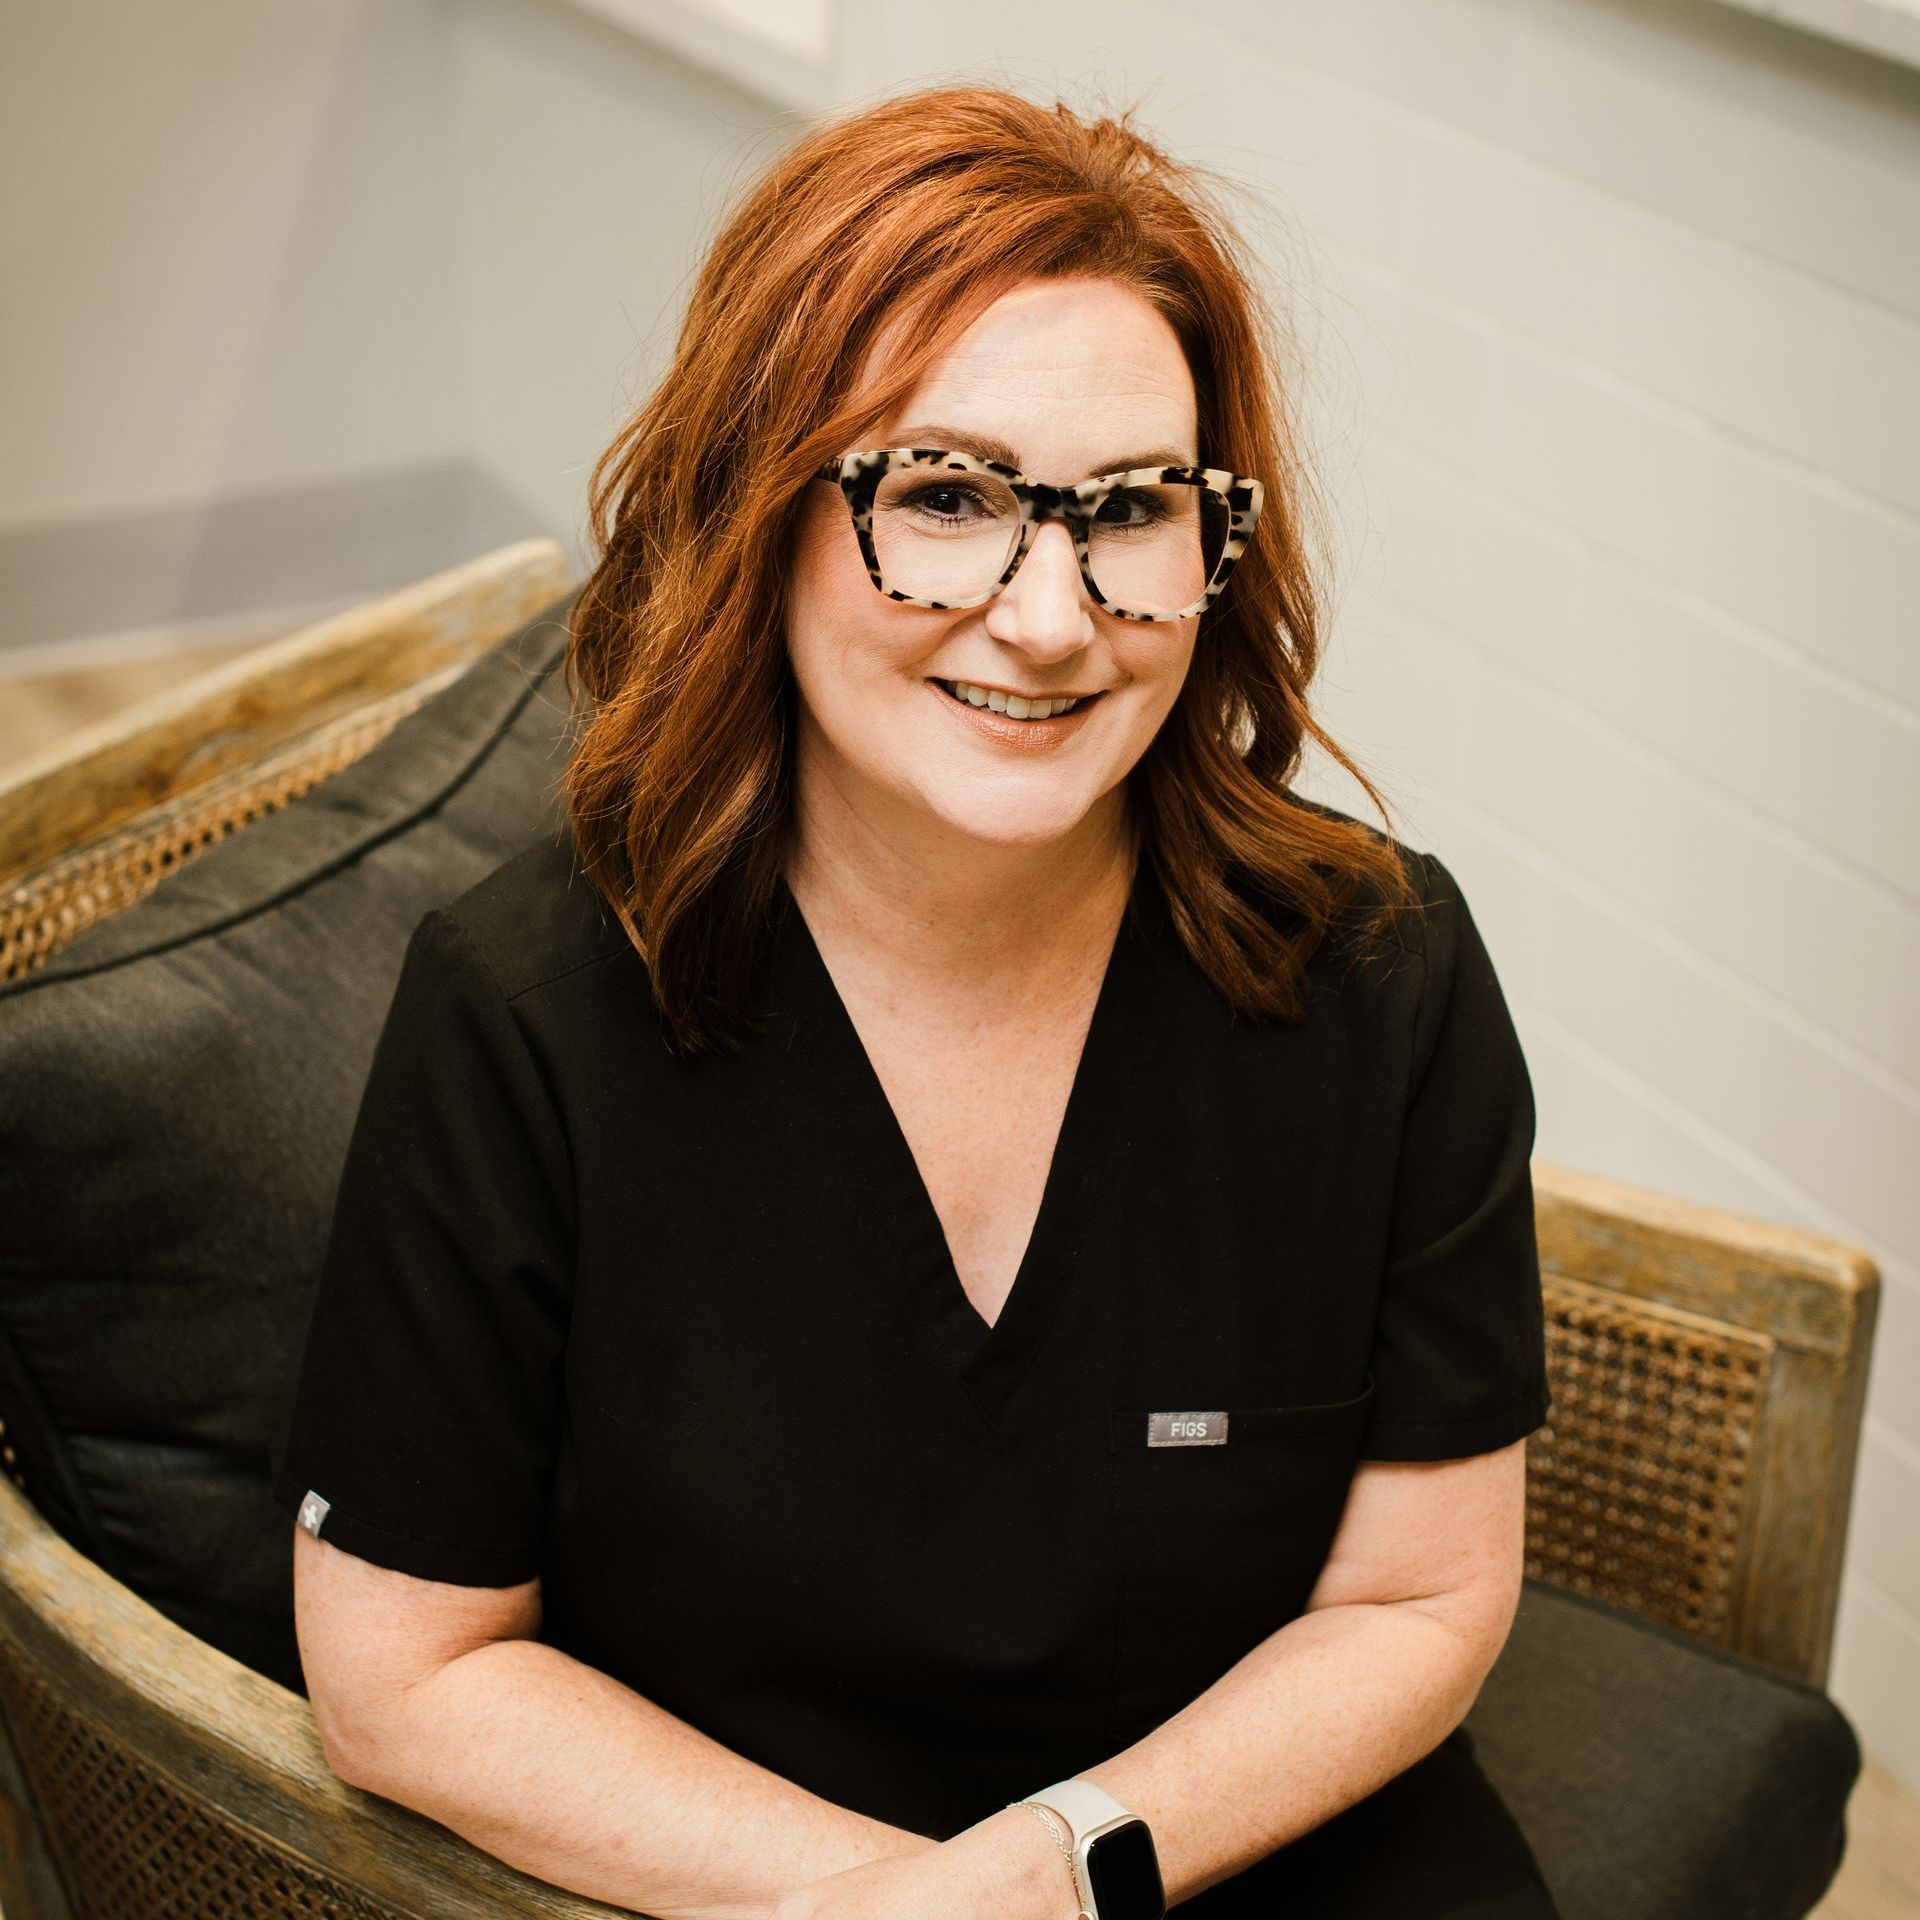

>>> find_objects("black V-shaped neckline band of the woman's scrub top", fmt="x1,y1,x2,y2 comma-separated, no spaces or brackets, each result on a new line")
778,860,1148,1427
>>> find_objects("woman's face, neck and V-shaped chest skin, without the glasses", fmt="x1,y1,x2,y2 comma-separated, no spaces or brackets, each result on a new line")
787,280,1200,1325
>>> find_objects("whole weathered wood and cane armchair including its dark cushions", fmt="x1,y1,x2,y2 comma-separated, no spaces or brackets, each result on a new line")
0,541,1878,1920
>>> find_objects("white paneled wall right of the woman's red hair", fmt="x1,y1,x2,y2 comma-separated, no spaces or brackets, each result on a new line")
845,0,1920,1789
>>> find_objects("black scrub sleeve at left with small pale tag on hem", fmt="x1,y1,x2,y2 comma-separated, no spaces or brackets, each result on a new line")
273,908,574,1586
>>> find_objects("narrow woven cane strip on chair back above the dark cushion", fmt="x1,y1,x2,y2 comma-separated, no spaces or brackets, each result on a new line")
0,674,447,979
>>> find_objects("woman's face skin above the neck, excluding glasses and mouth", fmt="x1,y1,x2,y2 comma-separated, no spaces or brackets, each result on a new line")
787,280,1200,849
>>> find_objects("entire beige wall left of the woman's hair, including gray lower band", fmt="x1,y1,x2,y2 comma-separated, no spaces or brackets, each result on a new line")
0,0,771,648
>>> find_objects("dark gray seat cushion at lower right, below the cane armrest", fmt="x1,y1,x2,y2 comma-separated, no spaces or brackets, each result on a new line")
1467,1580,1860,1920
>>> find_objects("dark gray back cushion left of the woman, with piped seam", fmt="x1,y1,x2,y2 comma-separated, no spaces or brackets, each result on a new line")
0,595,572,1688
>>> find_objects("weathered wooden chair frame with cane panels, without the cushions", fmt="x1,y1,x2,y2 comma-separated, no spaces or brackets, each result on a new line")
0,541,1878,1920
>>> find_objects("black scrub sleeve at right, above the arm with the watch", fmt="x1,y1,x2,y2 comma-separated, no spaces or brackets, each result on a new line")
1359,854,1551,1459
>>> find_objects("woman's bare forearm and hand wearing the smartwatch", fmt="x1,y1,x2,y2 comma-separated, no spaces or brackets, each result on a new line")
781,1440,1526,1920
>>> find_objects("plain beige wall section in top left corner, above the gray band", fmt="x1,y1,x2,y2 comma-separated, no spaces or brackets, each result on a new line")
0,0,467,528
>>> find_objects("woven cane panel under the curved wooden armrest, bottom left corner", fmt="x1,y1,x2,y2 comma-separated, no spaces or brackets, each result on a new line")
0,1647,409,1920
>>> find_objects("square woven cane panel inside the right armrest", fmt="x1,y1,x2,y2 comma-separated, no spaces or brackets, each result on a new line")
1526,1273,1774,1645
